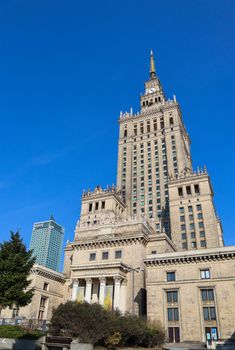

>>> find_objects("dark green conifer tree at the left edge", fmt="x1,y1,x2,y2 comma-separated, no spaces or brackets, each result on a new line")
0,231,35,313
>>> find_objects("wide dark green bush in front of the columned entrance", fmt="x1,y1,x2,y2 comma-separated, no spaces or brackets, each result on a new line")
50,302,165,347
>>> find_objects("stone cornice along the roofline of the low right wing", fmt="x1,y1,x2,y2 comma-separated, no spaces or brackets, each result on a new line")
144,246,235,267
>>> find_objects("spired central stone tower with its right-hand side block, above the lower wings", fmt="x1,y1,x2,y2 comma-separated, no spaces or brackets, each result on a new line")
117,51,223,250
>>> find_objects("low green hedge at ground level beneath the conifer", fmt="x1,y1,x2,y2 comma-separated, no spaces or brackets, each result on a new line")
0,325,44,339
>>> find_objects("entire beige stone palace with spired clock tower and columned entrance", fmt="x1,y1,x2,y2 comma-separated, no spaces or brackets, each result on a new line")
2,52,235,342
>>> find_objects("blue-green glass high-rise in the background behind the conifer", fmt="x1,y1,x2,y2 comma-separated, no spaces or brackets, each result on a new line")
30,215,64,272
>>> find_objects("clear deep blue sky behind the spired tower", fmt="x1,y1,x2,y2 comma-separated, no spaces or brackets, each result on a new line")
0,0,235,260
